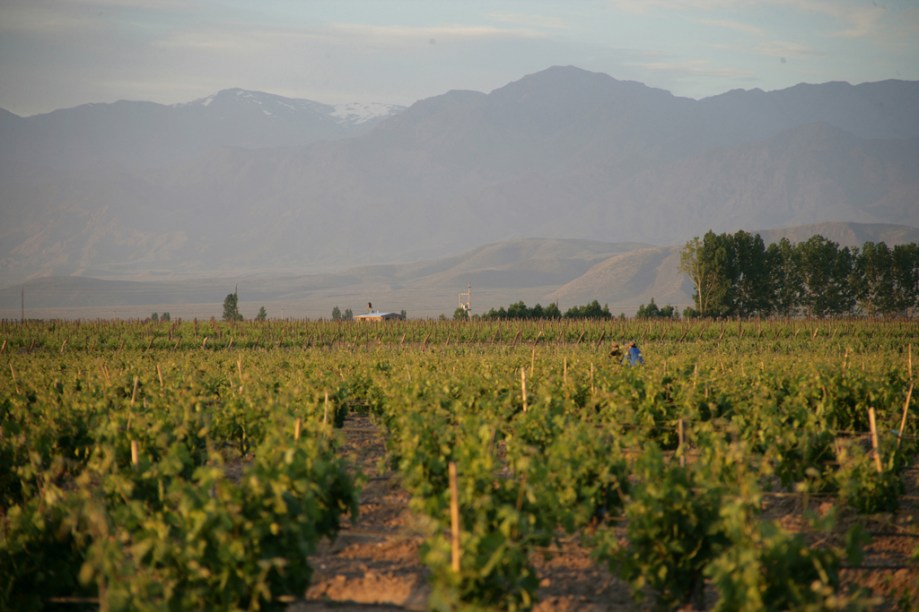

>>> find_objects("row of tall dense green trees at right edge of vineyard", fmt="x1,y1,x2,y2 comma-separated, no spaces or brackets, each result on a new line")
680,231,919,318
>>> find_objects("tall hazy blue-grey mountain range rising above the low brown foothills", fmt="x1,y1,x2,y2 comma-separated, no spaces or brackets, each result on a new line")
0,67,919,318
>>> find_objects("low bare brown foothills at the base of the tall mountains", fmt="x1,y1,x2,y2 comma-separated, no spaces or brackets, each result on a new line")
0,223,919,318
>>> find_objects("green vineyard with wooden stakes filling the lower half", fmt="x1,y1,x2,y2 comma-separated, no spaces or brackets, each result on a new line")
0,319,919,610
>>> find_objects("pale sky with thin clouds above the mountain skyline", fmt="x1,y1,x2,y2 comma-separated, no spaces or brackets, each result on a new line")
0,0,919,116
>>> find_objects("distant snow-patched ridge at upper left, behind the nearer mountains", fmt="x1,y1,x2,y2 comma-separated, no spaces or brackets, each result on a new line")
0,89,403,172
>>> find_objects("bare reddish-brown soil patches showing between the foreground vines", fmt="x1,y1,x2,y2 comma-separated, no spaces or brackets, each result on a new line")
290,414,919,612
